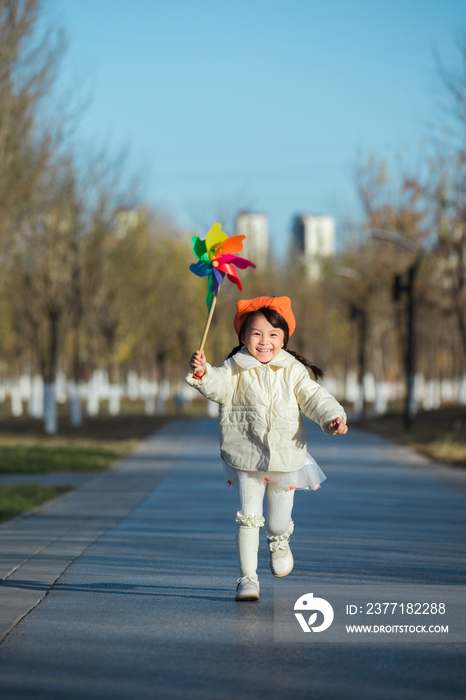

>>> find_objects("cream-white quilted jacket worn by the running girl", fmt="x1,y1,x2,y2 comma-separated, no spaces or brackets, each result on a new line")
186,348,346,472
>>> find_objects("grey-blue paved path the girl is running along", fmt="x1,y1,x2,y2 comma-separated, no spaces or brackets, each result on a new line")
0,420,466,700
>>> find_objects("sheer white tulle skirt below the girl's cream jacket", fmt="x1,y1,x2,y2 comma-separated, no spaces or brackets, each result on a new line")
223,452,327,491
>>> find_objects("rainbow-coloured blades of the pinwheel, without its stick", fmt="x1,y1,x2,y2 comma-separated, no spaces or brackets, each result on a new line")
189,224,256,310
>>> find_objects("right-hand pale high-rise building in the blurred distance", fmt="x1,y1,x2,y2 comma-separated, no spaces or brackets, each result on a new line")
292,214,335,279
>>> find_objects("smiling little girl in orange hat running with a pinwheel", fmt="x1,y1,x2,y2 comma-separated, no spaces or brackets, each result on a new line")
186,297,348,601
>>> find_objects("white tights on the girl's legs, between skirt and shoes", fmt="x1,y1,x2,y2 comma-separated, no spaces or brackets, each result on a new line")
235,479,294,577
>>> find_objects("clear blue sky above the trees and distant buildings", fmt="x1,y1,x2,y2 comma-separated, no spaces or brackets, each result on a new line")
54,0,466,255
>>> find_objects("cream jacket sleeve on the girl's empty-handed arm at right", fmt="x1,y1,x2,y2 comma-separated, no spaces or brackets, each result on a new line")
293,366,346,435
